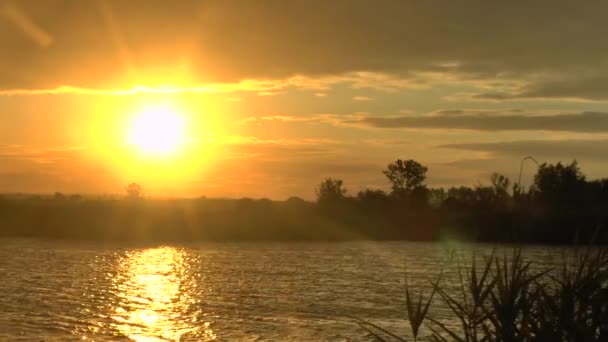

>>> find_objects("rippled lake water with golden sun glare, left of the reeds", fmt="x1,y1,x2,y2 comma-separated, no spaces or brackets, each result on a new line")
0,239,560,341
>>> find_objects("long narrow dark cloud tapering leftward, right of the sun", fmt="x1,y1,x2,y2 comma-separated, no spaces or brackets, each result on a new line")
354,112,608,133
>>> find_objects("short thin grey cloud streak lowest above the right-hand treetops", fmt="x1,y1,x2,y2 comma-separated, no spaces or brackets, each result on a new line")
439,139,608,161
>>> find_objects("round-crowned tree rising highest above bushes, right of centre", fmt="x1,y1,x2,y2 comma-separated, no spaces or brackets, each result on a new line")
382,159,428,194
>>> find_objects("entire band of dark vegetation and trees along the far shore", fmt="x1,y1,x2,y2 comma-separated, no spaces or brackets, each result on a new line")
0,160,608,243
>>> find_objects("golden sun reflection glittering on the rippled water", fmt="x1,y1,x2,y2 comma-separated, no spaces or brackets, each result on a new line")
112,247,216,342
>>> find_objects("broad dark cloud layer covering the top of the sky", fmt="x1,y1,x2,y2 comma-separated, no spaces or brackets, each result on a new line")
0,0,608,89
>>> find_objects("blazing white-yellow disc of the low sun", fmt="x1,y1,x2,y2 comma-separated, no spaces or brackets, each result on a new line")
127,106,186,157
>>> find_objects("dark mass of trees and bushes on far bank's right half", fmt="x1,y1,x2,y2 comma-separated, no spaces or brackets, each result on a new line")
316,159,608,243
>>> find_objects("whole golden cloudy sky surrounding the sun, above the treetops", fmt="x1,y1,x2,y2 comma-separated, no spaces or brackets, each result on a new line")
0,0,608,199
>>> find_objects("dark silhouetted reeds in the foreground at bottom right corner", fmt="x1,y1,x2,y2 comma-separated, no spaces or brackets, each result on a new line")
358,247,608,342
